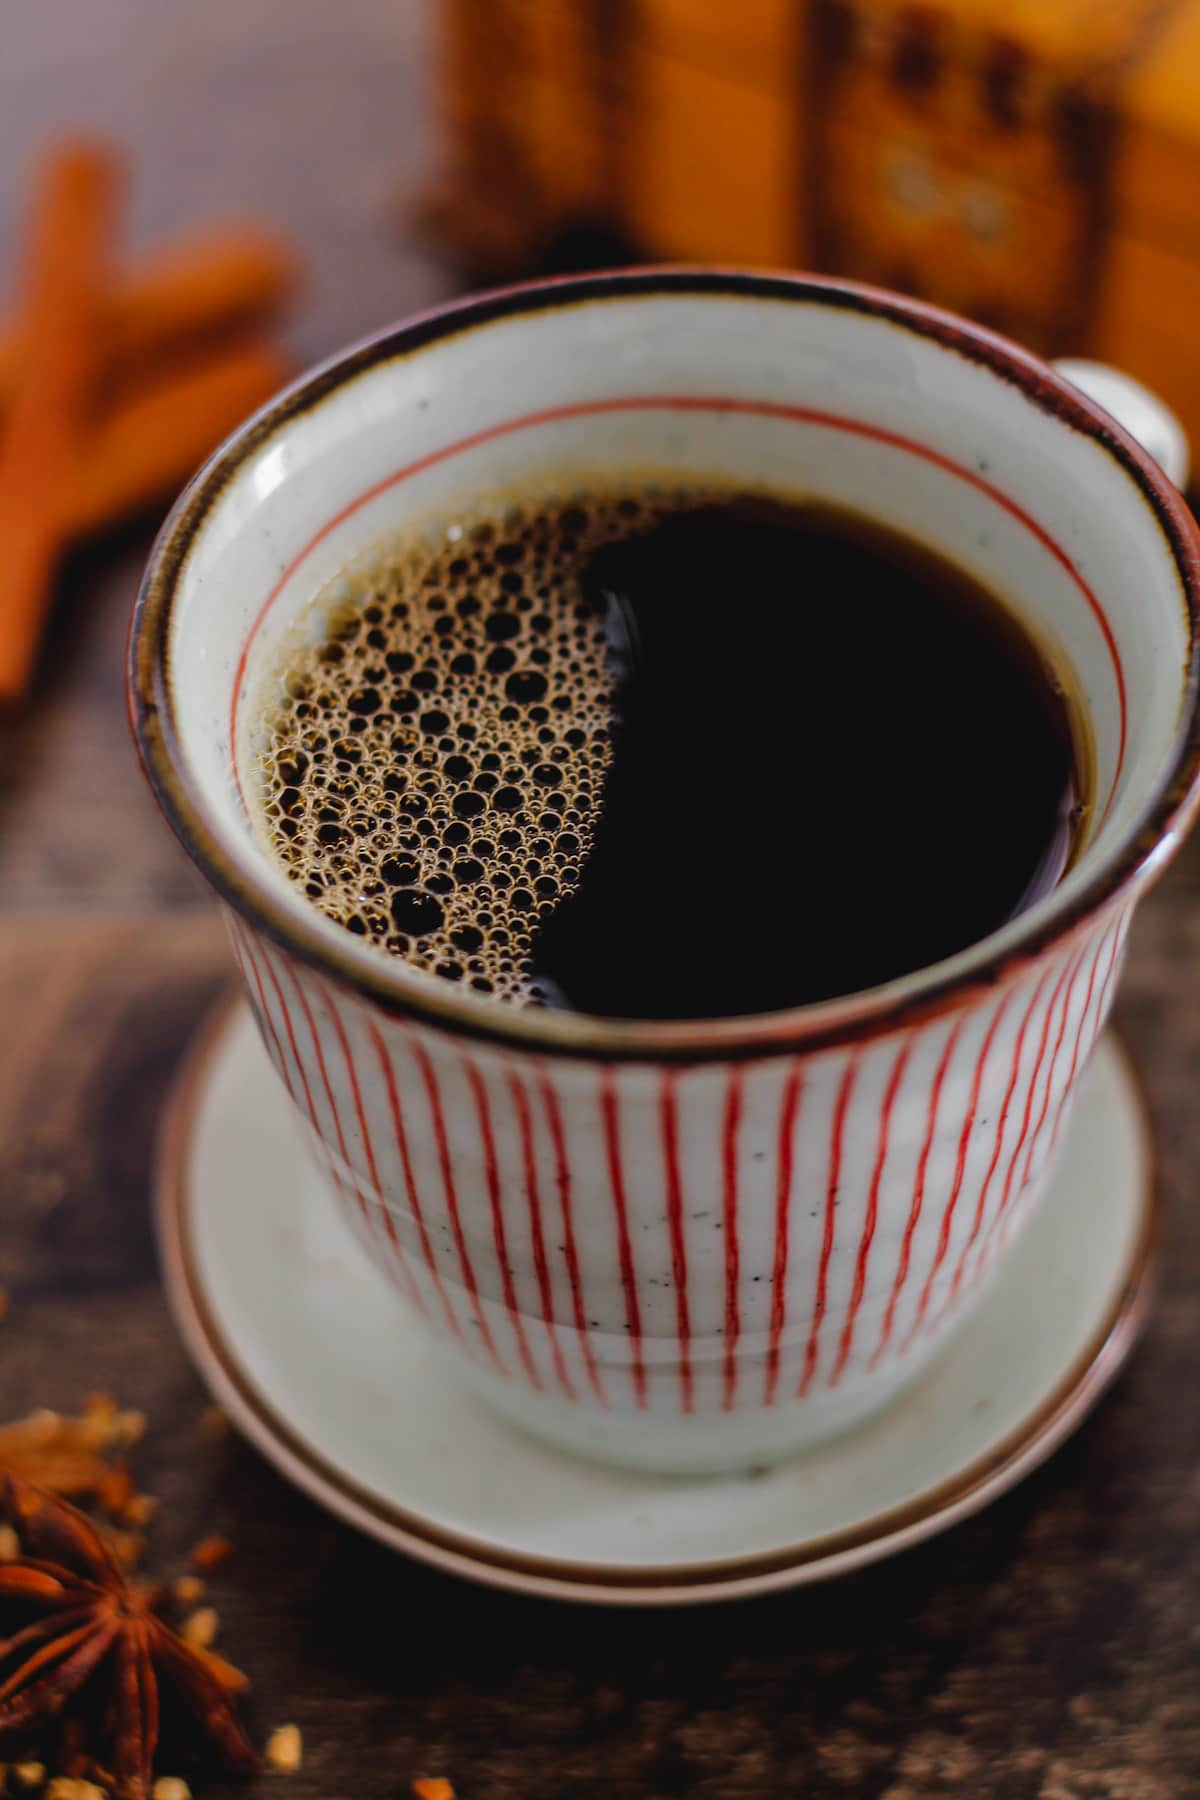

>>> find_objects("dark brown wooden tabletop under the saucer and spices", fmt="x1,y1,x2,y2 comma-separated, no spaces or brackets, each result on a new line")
0,0,1200,1800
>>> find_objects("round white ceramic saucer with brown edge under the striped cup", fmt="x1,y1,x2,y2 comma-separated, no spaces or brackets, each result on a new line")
158,1006,1155,1604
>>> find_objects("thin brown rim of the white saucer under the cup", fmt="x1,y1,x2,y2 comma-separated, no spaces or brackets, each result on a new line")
153,990,1162,1606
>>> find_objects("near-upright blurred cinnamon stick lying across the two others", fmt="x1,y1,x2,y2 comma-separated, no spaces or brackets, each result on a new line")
0,142,119,702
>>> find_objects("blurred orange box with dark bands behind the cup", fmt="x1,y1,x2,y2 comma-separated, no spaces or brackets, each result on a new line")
435,0,1200,446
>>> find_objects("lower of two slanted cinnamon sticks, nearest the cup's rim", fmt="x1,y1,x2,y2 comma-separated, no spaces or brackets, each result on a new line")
67,342,290,535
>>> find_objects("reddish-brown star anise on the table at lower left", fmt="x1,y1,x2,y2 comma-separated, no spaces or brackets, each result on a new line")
0,1476,259,1800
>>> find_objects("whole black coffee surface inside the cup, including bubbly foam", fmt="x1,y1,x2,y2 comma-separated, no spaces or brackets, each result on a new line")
263,488,1085,1019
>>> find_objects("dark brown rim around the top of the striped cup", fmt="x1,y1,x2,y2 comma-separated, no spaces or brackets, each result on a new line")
128,266,1200,1062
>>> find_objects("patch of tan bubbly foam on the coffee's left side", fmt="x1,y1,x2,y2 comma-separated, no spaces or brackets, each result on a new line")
255,490,682,1003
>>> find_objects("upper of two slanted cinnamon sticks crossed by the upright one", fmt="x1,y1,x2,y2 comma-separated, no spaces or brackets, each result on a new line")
0,225,297,401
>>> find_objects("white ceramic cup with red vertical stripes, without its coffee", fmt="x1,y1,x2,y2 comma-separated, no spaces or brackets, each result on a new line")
130,270,1200,1471
